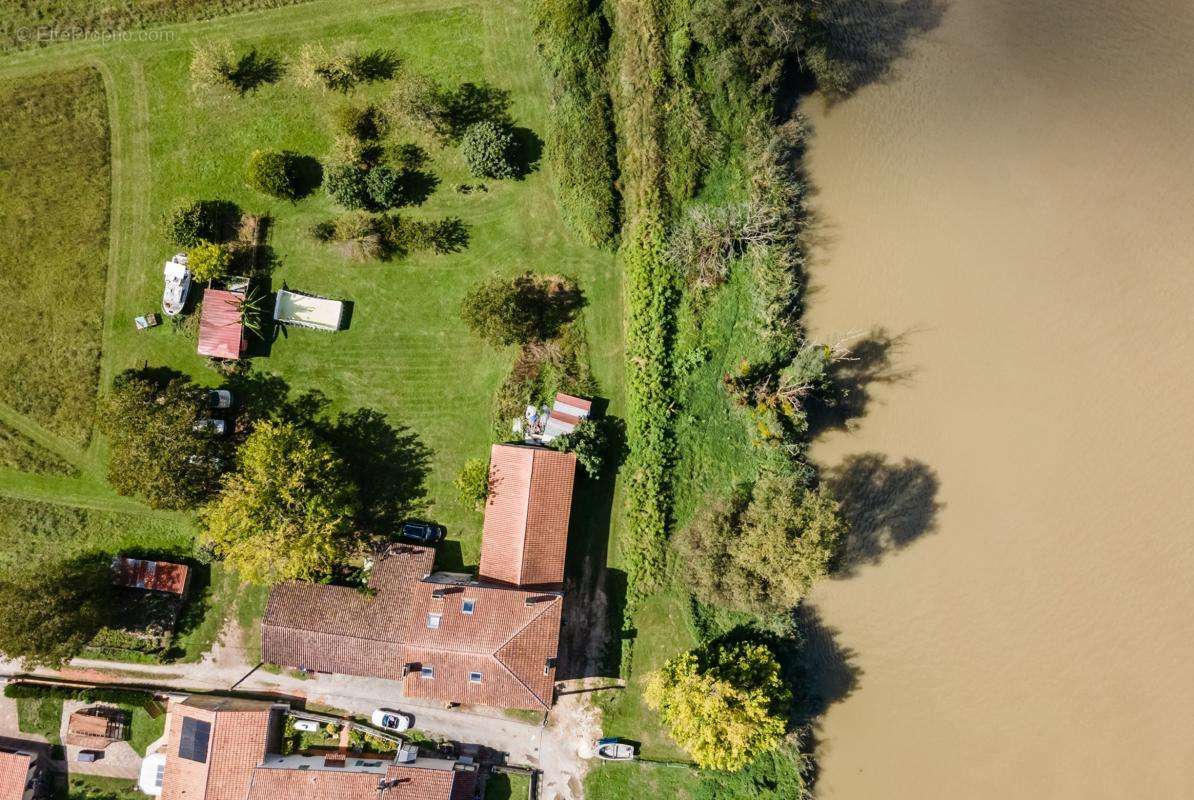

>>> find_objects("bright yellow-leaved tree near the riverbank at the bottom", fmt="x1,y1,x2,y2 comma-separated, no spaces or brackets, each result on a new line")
645,642,792,771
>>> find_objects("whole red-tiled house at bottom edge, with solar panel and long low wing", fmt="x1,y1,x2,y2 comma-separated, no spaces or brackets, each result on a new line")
151,697,476,800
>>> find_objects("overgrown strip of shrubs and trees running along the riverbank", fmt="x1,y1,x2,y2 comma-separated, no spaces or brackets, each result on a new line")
527,0,864,796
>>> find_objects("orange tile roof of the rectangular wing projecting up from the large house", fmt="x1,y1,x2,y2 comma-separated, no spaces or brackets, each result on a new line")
480,444,577,586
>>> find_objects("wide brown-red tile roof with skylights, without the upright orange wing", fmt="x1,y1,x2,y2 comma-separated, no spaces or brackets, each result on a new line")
261,546,564,709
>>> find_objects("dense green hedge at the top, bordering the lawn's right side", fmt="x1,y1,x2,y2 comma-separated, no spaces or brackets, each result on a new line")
533,0,618,245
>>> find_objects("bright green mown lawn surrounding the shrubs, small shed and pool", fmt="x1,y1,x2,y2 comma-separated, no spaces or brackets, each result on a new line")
0,0,622,660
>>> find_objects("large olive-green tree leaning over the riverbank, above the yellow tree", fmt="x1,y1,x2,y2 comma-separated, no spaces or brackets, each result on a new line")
678,475,847,614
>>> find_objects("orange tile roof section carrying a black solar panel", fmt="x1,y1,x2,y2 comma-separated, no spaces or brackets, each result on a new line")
161,697,273,800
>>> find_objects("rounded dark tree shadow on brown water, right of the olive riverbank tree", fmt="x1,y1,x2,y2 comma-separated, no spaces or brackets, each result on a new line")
825,453,942,577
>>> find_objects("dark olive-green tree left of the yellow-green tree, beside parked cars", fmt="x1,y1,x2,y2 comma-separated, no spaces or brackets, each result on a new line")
99,369,228,509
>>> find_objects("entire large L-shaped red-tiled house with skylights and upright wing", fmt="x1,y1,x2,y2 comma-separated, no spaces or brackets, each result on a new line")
261,444,577,710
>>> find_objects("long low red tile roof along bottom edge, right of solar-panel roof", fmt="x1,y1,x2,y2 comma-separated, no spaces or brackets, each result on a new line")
247,762,476,800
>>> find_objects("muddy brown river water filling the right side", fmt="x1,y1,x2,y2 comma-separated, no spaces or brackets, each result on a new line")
804,0,1194,800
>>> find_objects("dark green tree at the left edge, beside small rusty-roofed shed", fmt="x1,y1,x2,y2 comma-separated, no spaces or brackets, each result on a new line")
0,556,112,667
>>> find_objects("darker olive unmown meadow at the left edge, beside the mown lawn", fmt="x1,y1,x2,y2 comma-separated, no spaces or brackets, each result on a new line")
0,69,110,445
